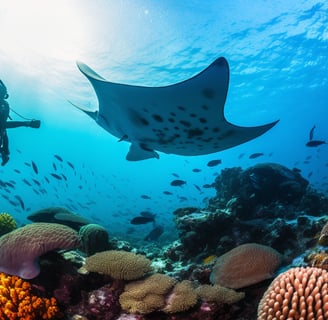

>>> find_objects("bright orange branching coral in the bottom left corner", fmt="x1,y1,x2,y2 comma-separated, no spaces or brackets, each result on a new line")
0,273,61,320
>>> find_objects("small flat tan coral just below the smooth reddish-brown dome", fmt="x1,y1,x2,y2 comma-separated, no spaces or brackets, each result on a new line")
196,284,245,304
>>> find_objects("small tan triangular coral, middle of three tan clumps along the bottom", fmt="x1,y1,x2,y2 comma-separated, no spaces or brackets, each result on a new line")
162,280,198,313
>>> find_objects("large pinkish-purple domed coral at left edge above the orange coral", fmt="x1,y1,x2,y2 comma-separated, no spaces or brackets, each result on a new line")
0,222,79,279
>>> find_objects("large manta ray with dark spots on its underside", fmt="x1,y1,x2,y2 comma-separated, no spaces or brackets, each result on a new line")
75,57,279,161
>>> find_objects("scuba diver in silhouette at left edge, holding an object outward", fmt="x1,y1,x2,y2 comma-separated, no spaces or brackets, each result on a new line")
0,80,41,166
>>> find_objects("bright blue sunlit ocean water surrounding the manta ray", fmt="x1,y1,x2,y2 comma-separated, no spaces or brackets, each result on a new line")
0,0,328,240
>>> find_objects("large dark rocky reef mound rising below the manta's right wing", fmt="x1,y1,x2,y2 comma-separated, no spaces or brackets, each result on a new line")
175,163,328,259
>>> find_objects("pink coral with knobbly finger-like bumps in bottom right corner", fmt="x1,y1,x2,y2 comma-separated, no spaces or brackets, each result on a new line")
257,267,328,320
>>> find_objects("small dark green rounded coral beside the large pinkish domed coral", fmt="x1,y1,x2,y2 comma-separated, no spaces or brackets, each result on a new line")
79,223,109,256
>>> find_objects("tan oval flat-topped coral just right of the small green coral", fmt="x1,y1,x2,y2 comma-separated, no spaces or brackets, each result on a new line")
83,250,152,280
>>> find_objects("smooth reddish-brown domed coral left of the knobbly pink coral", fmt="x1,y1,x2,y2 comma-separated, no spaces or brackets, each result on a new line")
210,243,281,289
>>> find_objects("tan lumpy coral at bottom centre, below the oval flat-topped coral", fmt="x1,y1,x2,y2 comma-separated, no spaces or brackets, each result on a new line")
120,273,176,314
